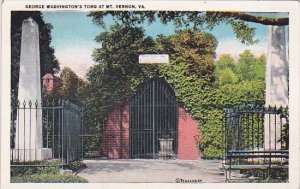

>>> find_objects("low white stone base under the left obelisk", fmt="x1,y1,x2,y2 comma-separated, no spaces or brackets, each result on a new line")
10,148,52,162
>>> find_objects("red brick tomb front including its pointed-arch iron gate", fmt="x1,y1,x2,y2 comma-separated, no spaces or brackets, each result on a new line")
99,78,200,160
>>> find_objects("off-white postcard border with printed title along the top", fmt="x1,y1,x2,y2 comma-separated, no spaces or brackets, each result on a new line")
0,0,300,189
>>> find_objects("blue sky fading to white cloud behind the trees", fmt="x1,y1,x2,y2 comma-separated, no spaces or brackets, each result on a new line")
43,11,268,78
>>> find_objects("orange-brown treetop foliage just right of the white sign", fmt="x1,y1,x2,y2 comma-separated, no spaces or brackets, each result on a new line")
157,29,218,81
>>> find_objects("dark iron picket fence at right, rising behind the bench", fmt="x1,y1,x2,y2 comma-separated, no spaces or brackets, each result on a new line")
224,104,289,152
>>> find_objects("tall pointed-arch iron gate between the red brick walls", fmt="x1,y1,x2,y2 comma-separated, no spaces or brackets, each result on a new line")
129,78,178,159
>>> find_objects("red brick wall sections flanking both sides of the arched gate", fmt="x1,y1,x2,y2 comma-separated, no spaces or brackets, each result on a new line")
99,104,200,160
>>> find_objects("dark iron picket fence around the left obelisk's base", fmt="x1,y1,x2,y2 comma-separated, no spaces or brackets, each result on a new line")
10,100,83,166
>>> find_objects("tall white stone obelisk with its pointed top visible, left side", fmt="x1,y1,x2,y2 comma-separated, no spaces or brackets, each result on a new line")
12,18,52,161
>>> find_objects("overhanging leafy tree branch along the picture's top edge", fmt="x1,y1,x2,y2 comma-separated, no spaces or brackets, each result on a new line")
89,11,289,44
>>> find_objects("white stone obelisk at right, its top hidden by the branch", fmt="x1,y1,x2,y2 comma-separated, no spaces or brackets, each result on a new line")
265,26,289,150
